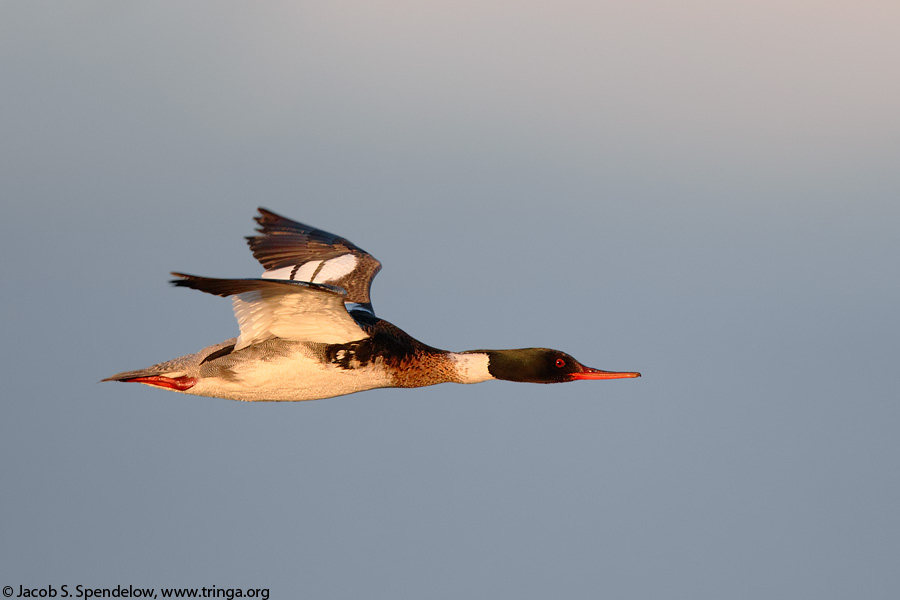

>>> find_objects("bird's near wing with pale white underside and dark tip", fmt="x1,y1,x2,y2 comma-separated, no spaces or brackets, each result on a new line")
172,273,368,350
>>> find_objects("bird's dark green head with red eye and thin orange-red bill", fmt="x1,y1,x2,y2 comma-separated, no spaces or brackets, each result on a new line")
472,348,641,383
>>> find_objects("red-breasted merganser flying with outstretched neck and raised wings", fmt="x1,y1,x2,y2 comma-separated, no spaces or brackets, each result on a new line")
103,208,641,401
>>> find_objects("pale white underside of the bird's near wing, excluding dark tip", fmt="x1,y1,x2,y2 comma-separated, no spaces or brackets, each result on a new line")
232,288,367,350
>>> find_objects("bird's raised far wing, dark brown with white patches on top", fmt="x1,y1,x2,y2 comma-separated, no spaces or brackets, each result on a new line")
247,208,381,312
